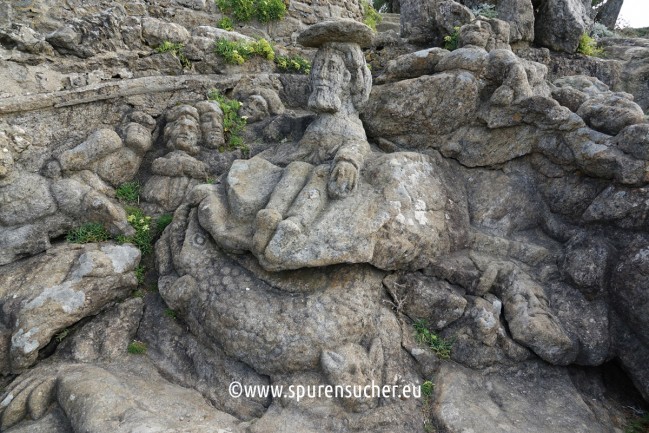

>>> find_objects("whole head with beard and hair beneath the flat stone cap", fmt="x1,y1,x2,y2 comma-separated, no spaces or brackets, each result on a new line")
309,42,372,113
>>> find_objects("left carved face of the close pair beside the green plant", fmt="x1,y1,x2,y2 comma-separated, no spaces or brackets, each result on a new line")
164,105,200,155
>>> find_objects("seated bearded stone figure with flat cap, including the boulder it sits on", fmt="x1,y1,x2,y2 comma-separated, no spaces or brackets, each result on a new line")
196,22,467,270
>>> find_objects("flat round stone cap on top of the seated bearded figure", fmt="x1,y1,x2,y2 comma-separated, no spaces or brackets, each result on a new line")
297,19,374,48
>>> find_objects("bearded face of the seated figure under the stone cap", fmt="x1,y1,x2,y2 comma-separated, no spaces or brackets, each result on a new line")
309,48,351,113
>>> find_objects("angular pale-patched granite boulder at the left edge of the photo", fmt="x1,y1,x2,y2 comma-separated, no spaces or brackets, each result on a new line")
0,243,140,374
